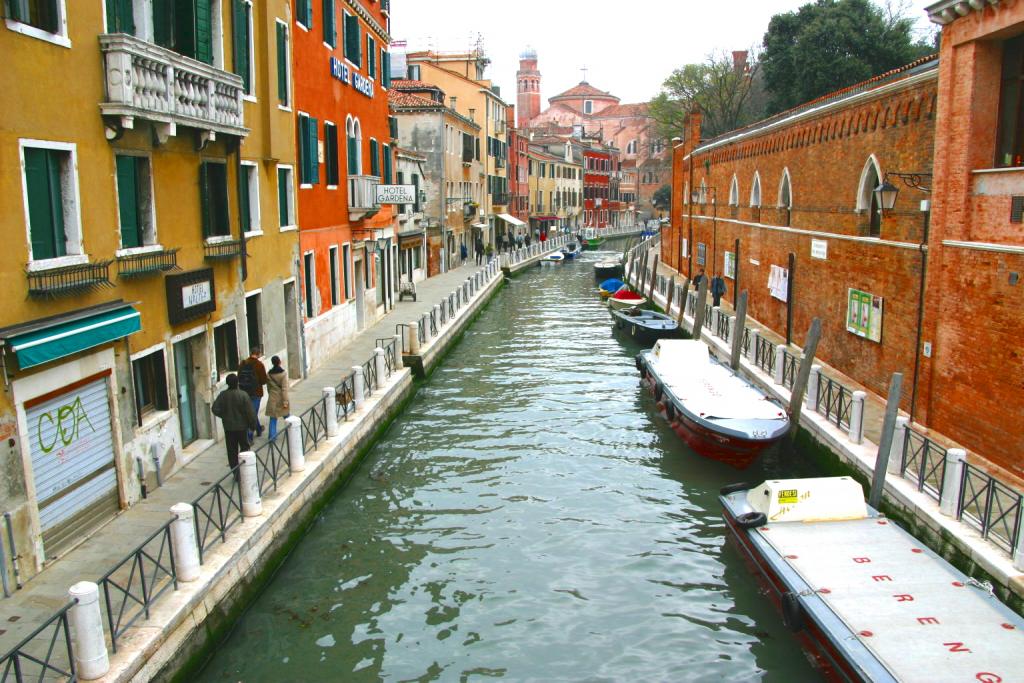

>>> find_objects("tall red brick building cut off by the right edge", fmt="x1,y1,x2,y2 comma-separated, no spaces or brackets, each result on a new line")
920,0,1024,476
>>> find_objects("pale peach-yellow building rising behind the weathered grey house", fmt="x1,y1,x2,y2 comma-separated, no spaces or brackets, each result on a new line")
406,50,509,251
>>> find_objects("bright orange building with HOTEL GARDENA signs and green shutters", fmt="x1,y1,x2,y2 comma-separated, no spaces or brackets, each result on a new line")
294,0,398,368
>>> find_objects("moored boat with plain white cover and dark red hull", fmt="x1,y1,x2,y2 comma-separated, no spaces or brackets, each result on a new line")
637,339,790,469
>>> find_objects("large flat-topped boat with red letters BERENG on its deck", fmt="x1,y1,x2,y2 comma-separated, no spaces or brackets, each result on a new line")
719,476,1024,682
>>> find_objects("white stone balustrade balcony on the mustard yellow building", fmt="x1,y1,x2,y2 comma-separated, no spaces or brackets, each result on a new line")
99,33,249,142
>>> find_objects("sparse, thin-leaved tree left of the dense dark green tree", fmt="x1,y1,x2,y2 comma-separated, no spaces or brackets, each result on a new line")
649,53,760,139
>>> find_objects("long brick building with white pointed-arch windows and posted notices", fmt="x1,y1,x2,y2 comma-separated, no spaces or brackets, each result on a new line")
662,56,938,440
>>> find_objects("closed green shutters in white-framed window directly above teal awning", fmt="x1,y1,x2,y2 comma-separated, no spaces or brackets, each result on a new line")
25,147,68,260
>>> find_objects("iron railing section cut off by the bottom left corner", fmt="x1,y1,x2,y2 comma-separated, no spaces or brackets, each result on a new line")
0,600,78,683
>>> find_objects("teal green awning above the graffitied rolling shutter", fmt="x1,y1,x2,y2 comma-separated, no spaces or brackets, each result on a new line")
0,303,142,370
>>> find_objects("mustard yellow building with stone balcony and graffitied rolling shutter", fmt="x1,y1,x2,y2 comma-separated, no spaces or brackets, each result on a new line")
0,0,302,578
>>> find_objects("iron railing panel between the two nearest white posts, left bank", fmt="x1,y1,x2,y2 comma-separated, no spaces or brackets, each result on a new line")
98,520,178,652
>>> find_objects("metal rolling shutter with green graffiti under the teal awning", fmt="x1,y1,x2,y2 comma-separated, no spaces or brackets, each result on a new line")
26,376,119,557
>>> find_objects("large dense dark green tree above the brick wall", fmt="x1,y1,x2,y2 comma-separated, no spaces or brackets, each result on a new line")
761,0,934,115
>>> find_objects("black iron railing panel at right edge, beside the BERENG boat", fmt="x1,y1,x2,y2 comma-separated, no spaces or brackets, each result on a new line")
954,464,1024,557
